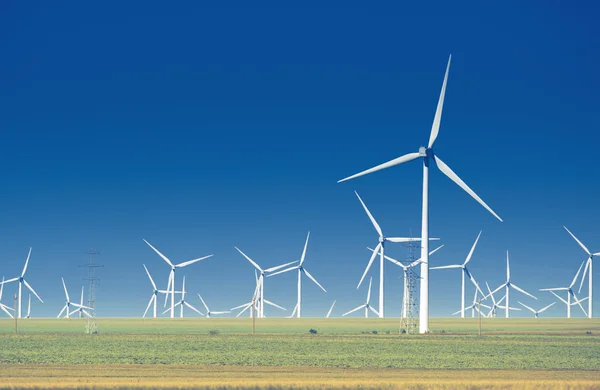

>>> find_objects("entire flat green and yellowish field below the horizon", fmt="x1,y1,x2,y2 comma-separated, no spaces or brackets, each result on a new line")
0,318,600,388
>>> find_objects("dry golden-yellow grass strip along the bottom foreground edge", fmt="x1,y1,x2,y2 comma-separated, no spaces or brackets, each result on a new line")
0,365,600,390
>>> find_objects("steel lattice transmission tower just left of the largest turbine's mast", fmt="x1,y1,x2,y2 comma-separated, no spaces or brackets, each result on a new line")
400,233,421,334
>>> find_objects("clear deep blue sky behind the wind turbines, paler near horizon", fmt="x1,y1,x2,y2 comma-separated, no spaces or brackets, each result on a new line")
0,2,600,316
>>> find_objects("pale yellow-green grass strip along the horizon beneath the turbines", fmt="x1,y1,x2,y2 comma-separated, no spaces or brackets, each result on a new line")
0,318,600,335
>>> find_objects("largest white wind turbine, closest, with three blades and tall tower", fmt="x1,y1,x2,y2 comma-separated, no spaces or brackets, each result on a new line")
338,56,502,333
